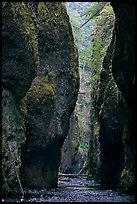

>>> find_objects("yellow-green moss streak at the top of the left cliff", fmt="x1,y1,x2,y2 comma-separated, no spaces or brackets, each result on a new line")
11,2,39,64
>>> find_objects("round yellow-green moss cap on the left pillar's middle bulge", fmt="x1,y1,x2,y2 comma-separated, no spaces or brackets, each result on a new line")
27,76,55,104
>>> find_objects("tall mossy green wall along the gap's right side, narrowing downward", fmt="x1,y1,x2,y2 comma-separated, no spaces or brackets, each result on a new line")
80,2,114,179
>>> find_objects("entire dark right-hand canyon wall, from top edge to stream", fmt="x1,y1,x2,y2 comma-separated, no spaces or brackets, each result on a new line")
89,2,135,194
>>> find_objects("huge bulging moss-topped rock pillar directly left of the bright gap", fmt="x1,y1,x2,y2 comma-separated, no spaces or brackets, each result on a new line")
21,2,79,188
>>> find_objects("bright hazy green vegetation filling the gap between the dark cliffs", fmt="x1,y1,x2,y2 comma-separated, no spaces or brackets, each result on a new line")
68,2,114,156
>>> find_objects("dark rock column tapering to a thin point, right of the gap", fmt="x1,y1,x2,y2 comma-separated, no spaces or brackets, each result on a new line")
97,36,125,188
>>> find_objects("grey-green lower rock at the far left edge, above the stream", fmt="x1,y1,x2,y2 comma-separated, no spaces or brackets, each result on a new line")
2,89,25,194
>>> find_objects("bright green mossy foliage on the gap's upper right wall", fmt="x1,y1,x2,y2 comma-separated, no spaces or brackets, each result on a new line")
80,2,114,73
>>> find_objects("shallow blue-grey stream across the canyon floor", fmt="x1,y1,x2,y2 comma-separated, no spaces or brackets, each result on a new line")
2,178,135,202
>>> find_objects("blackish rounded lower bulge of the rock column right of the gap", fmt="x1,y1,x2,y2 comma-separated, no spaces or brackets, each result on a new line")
99,79,125,189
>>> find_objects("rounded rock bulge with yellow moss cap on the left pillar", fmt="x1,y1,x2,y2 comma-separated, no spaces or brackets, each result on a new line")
22,75,55,150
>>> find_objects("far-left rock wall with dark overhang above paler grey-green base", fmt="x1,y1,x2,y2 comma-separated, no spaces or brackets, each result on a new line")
2,2,37,194
